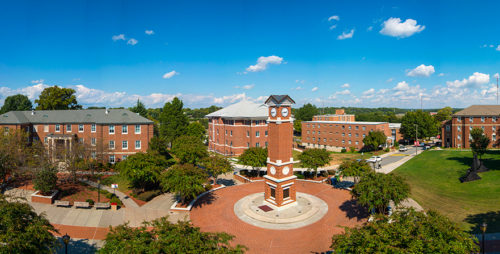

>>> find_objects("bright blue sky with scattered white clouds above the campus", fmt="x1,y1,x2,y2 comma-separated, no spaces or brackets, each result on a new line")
0,0,500,108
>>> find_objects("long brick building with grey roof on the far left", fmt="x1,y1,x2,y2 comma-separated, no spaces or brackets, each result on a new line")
0,109,153,163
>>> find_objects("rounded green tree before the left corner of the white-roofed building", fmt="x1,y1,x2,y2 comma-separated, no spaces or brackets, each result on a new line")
172,136,208,164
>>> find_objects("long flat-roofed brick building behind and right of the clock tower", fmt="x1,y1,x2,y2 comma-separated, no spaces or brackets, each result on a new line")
302,110,403,151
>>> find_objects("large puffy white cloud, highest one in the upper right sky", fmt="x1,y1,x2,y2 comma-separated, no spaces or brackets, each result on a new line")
380,18,425,38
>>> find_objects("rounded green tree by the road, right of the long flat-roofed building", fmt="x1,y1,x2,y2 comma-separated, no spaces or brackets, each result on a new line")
400,110,440,139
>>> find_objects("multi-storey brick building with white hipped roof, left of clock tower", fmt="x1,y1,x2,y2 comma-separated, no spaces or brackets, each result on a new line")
206,100,268,156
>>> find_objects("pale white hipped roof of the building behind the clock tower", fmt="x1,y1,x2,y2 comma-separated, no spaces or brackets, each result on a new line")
206,100,269,120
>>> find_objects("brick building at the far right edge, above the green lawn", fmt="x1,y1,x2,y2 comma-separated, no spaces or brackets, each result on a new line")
441,105,500,148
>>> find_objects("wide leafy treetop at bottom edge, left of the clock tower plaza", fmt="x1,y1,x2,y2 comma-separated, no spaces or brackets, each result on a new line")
99,217,247,254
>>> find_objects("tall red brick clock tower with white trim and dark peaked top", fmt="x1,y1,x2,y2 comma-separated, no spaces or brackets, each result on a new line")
264,95,297,210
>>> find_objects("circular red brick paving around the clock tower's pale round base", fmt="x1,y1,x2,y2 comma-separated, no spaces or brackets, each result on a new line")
191,181,367,253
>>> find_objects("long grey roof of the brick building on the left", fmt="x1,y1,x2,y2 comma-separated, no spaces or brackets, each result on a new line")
0,109,153,124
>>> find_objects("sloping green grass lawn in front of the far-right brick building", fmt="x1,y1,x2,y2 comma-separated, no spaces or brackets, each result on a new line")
394,150,500,233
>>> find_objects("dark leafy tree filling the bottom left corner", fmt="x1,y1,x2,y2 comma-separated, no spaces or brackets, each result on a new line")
0,194,58,253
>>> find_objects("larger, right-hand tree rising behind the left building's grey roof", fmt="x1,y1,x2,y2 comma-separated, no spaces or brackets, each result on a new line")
35,86,82,110
